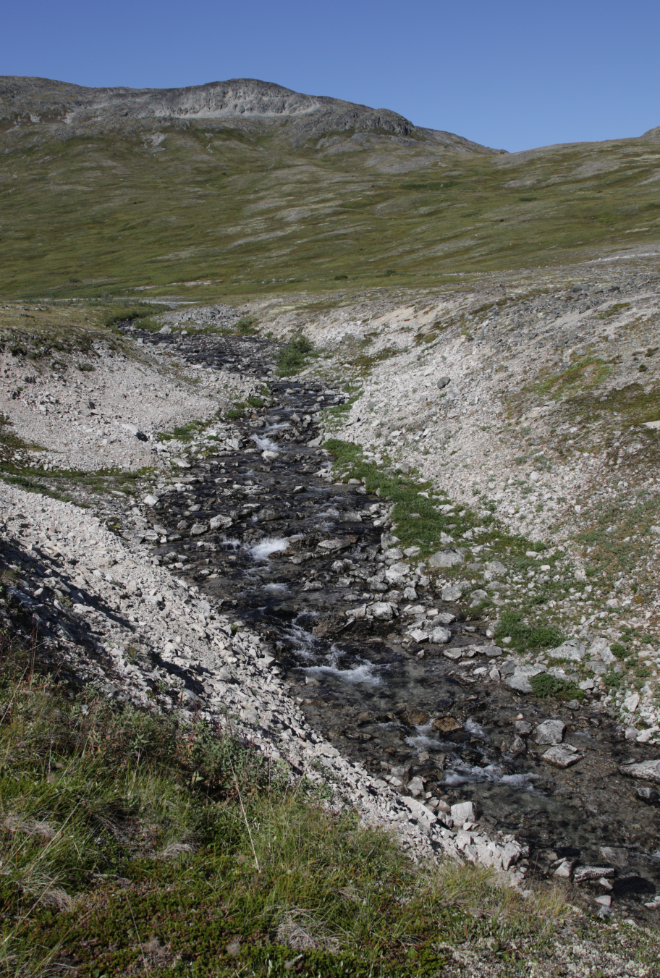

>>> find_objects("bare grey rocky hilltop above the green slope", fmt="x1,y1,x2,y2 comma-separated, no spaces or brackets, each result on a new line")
0,76,504,154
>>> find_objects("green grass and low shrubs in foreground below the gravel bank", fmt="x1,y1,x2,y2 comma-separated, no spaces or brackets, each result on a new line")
0,635,592,978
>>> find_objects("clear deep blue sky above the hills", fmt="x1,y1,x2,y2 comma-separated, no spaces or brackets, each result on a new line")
0,0,660,150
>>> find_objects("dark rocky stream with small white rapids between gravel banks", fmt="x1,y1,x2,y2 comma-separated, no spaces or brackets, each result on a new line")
127,329,660,913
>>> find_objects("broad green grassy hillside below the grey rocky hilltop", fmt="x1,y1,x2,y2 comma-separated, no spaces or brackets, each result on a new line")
0,123,660,299
